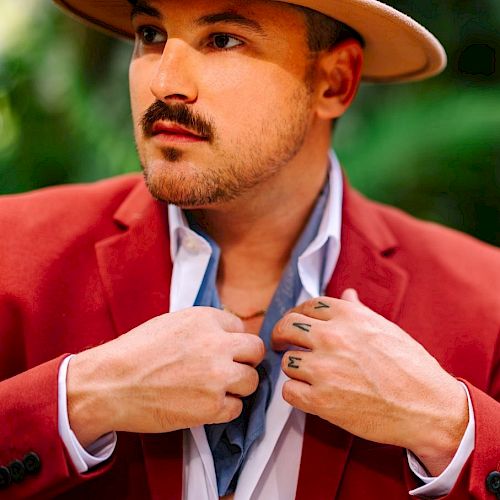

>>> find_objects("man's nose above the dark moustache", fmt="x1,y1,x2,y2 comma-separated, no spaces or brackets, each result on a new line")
150,38,198,103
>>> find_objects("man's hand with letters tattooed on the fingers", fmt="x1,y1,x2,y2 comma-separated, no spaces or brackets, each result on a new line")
273,290,468,475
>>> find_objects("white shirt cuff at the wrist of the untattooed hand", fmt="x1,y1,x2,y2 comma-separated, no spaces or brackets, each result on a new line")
57,356,117,474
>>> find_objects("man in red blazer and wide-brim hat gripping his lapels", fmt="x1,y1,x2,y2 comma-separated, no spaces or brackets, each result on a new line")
0,0,500,500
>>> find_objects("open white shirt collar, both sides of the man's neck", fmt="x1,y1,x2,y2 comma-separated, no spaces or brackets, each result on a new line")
168,150,343,297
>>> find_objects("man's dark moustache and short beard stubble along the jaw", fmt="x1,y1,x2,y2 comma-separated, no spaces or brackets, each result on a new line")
138,83,312,208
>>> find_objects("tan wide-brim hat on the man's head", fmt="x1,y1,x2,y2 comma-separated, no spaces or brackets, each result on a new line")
54,0,446,82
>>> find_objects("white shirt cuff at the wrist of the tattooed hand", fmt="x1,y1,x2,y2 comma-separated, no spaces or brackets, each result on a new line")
406,382,476,497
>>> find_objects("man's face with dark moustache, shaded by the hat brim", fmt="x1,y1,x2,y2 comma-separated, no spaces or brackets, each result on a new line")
130,0,312,207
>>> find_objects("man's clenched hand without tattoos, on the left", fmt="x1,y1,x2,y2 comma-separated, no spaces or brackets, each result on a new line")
67,307,265,446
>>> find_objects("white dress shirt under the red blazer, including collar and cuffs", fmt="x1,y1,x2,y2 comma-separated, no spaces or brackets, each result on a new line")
59,152,475,500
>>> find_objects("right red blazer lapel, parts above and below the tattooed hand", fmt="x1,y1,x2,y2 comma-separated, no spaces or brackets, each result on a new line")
296,178,408,500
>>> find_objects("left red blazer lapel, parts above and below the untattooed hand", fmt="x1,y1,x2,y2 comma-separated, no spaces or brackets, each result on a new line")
95,182,182,500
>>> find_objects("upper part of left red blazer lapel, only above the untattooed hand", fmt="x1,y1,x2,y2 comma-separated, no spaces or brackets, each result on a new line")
96,182,172,335
